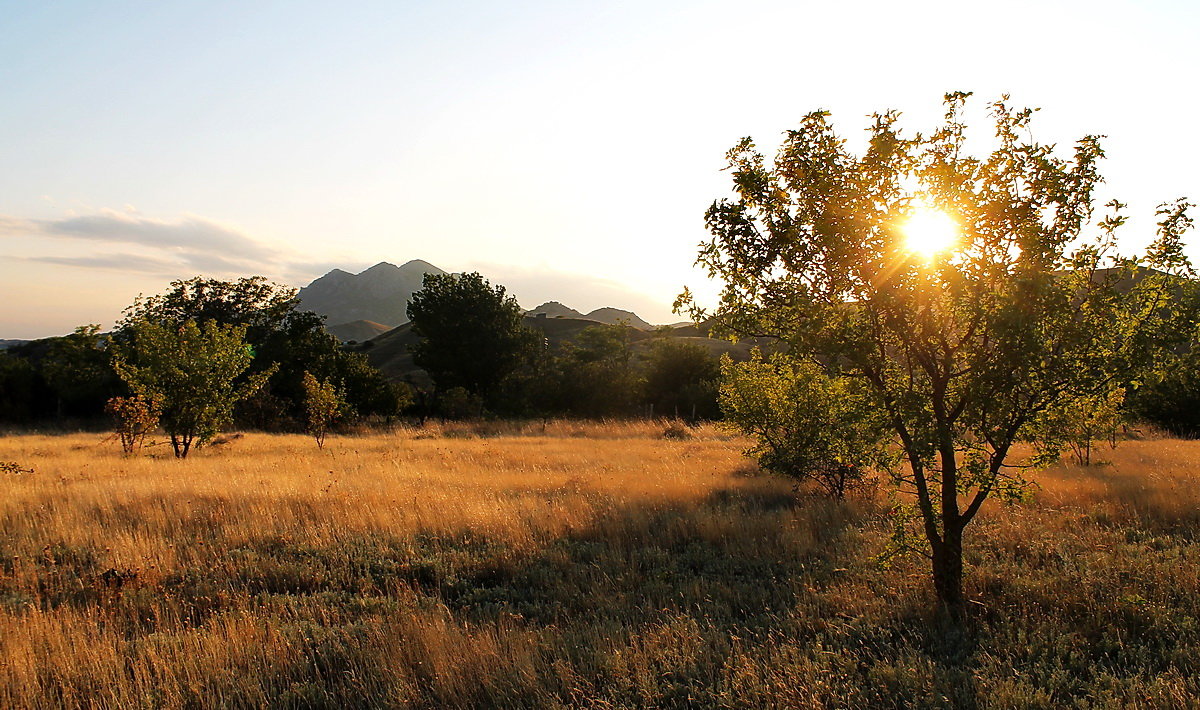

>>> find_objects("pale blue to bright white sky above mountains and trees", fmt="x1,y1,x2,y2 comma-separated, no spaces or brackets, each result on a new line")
0,0,1200,338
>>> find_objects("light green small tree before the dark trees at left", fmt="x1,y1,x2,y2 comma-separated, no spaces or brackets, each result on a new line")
113,320,275,458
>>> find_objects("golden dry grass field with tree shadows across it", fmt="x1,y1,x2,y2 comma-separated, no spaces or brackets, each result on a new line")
0,422,1200,709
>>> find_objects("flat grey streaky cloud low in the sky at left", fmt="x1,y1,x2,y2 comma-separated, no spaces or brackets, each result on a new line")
0,205,286,276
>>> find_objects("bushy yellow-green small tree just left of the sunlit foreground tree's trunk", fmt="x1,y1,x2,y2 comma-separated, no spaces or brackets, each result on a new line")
720,351,896,500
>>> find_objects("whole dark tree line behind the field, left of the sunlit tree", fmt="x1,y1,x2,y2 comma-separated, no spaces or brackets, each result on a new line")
0,273,720,443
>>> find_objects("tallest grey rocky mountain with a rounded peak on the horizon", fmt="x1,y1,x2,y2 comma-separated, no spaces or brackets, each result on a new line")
298,259,445,326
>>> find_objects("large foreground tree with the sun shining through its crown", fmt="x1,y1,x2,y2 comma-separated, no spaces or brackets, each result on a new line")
677,94,1189,619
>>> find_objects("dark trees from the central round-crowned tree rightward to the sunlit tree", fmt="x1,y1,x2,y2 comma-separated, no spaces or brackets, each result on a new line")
408,273,720,419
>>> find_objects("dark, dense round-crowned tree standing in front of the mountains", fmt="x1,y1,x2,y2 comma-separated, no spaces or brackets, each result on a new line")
408,273,539,401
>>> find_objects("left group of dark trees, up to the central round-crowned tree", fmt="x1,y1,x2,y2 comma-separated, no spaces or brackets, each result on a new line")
0,276,410,431
